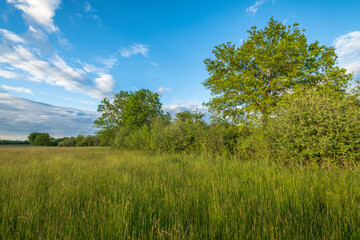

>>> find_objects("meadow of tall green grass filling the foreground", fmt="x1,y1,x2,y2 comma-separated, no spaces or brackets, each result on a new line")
0,147,360,239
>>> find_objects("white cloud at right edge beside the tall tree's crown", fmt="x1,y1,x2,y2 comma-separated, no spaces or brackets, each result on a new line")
334,31,360,76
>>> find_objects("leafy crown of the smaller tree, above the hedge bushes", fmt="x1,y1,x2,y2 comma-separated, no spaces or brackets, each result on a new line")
94,89,165,136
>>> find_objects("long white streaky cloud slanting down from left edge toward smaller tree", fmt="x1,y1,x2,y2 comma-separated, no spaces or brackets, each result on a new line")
0,29,114,98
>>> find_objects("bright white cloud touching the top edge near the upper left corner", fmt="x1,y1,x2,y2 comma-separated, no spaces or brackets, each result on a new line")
7,0,61,32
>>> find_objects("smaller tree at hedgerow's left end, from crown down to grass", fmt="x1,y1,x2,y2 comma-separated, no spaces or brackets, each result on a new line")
94,89,165,149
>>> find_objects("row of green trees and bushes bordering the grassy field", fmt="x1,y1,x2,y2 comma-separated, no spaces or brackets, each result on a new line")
28,18,360,166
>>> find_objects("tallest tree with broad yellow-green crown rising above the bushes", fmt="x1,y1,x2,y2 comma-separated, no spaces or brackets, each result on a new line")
203,18,352,126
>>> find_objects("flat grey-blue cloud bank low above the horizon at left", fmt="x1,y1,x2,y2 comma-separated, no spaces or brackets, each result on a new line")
0,91,97,139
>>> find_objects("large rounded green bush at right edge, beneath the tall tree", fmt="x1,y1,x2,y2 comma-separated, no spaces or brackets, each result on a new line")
269,92,360,166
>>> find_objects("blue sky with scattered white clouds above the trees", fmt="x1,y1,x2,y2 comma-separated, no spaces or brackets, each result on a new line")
0,0,360,139
